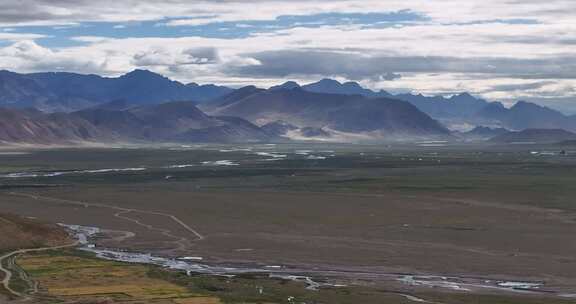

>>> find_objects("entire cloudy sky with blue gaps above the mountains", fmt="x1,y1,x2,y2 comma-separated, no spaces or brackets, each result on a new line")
0,0,576,113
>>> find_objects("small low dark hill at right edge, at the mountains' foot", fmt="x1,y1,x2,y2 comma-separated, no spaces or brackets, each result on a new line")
490,129,576,144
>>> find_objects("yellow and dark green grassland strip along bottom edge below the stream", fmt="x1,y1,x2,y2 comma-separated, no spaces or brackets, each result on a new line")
18,251,570,304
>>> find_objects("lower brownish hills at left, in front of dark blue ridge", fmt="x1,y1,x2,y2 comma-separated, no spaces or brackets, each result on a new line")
0,102,276,145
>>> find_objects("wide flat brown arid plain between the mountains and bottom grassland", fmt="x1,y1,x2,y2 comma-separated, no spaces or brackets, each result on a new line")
0,145,576,303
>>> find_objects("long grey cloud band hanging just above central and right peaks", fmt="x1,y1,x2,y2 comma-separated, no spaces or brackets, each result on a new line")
231,50,576,80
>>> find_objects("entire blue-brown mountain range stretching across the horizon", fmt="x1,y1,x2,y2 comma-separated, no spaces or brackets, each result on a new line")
0,70,576,143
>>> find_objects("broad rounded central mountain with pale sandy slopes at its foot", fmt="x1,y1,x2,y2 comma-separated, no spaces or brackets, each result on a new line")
211,88,449,140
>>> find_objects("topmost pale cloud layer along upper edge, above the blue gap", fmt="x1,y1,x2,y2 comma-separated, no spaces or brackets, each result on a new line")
0,0,576,25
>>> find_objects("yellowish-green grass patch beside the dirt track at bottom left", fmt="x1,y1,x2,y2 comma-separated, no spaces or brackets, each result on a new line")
18,252,220,304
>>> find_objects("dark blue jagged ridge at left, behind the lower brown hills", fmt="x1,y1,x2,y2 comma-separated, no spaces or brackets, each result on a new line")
0,70,233,112
